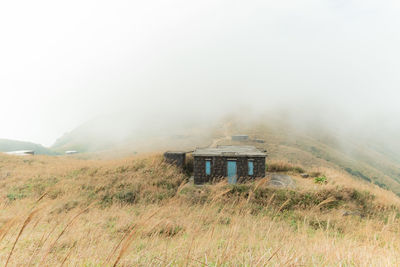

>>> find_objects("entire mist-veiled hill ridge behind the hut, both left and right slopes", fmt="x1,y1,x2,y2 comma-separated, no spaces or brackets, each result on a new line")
52,116,400,197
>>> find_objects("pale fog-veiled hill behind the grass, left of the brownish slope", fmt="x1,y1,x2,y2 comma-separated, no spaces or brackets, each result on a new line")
51,114,214,153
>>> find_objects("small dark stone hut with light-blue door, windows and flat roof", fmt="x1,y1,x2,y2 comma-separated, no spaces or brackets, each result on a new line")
193,146,267,184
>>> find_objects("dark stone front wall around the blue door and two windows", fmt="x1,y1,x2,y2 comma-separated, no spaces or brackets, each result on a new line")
193,156,265,184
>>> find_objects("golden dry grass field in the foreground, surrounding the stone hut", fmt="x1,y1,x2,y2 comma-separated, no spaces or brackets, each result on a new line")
0,154,400,266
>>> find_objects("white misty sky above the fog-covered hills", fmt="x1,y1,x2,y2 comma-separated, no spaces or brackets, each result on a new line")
0,0,400,145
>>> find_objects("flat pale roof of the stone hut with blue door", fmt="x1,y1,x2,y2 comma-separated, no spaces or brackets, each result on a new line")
193,146,266,157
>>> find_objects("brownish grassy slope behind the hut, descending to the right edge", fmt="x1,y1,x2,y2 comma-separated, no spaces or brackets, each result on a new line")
214,121,400,195
